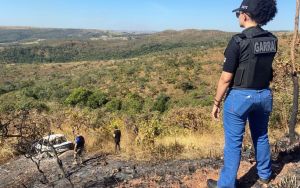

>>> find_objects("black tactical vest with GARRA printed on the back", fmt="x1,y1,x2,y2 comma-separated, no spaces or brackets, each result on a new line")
231,30,278,89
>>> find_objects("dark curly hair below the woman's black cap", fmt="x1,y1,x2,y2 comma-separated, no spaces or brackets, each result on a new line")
250,0,277,26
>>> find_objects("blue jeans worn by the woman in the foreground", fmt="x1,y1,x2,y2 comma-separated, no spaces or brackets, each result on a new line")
218,89,273,188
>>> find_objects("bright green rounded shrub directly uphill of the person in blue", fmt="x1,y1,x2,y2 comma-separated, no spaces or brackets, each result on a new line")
65,87,92,106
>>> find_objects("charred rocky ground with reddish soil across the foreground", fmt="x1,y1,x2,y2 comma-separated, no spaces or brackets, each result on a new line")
0,137,300,188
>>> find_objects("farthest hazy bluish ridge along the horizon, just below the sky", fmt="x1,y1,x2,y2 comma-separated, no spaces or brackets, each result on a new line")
0,27,231,45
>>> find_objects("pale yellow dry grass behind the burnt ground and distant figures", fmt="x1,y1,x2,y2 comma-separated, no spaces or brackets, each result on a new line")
45,120,300,161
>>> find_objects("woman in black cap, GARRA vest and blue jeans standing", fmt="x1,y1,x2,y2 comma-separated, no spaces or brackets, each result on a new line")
207,0,277,188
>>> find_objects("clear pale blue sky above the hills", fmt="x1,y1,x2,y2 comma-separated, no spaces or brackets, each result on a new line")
0,0,296,31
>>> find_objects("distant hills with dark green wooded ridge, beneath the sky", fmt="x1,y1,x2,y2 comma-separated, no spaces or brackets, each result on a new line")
0,28,233,63
